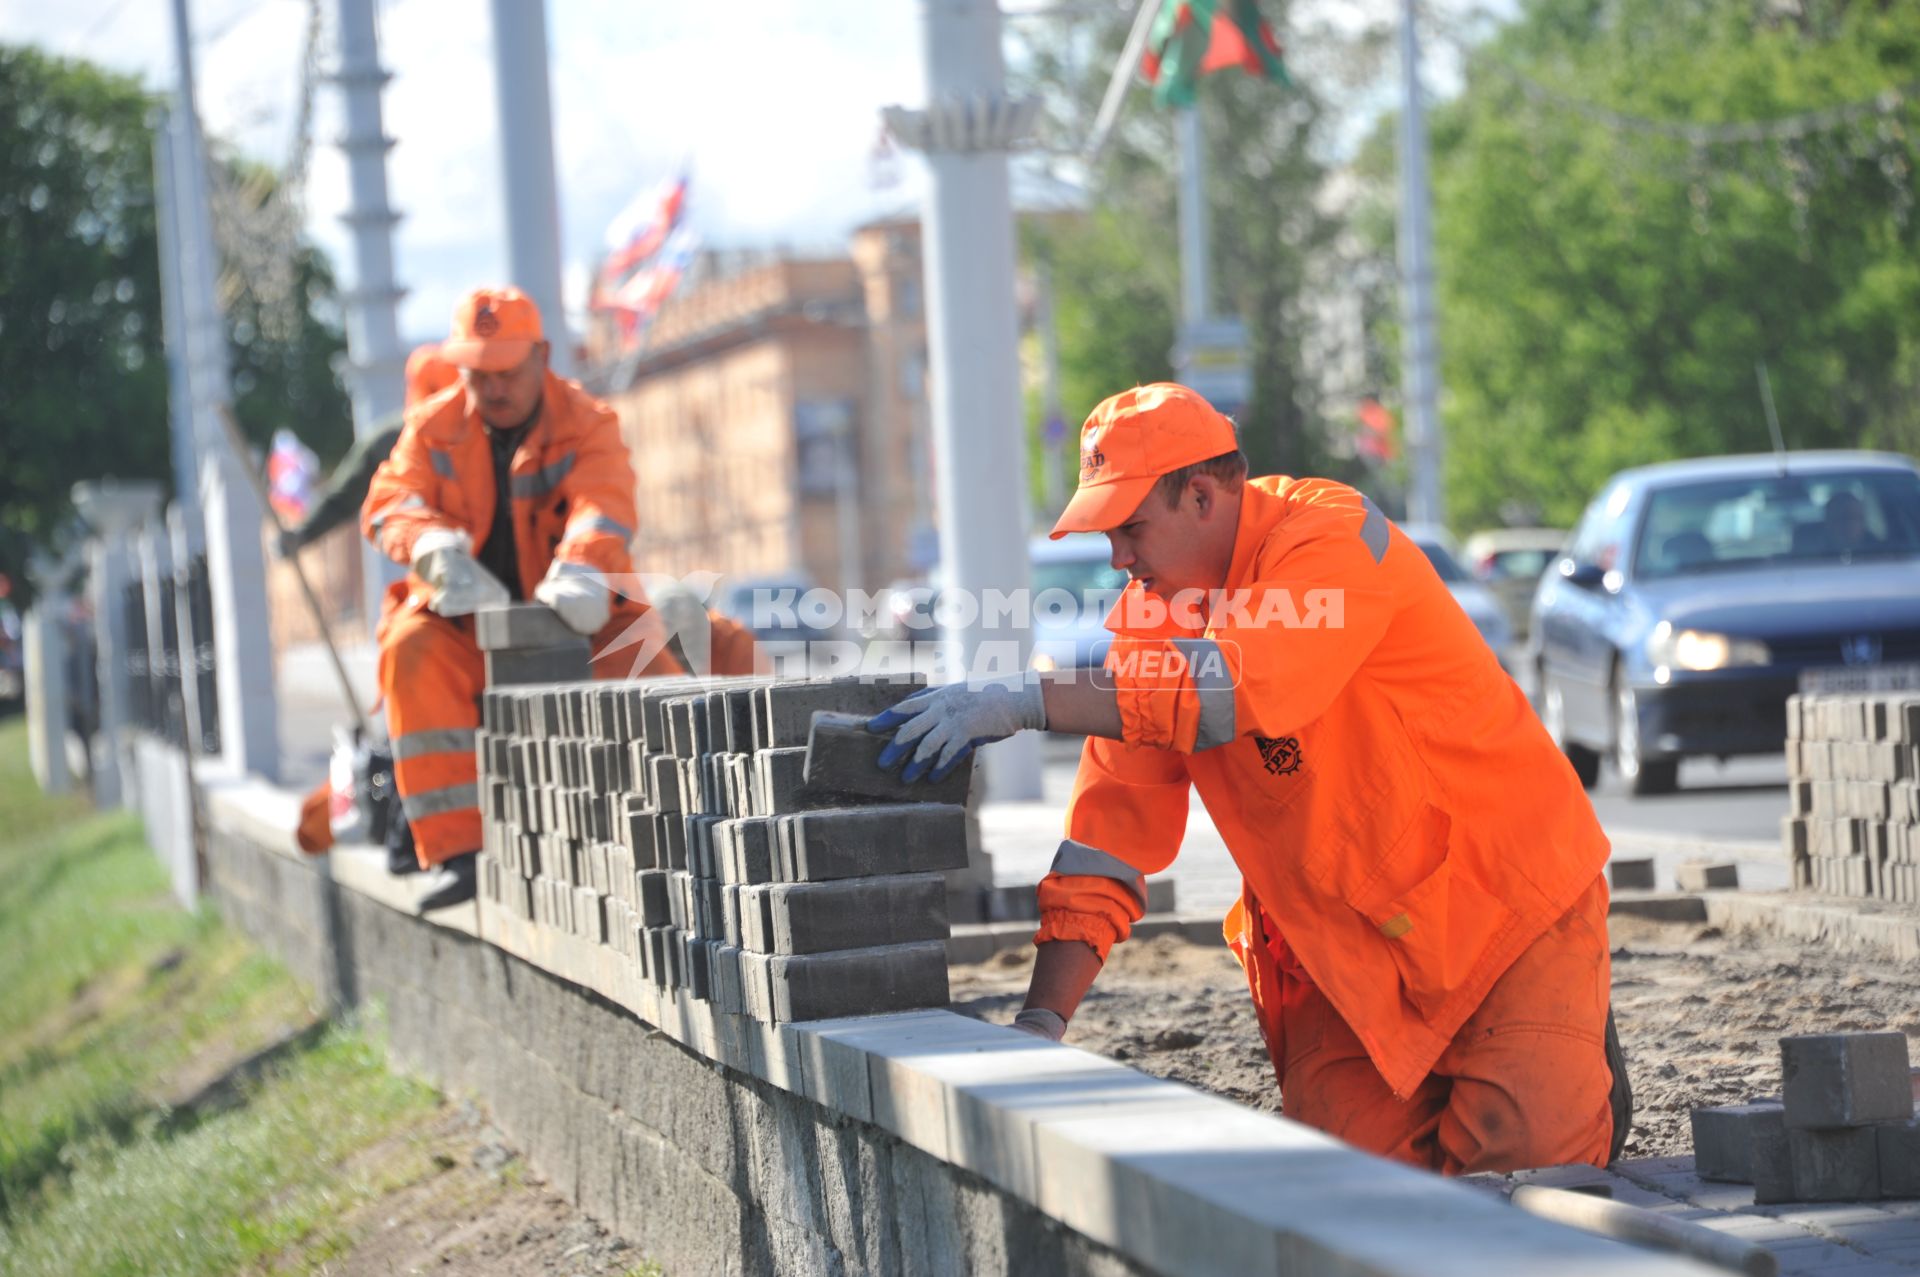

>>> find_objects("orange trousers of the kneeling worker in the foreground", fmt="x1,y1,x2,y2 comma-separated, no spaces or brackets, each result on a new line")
1236,878,1624,1175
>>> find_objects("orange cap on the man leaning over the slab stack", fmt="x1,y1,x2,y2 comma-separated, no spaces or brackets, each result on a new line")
1048,382,1240,542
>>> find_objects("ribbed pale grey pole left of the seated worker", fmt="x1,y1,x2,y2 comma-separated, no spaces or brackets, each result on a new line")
332,0,407,626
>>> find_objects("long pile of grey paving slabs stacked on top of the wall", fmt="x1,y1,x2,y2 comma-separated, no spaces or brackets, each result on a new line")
478,678,972,1024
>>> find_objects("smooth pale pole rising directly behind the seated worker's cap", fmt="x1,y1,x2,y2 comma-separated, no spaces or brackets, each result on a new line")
492,0,574,376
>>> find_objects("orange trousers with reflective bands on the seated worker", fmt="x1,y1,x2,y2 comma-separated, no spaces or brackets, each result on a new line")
380,609,682,866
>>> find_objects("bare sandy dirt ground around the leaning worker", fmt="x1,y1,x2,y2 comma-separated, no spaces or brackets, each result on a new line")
952,918,1920,1158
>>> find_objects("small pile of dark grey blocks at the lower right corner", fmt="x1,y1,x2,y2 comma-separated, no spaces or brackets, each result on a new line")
1693,1033,1920,1206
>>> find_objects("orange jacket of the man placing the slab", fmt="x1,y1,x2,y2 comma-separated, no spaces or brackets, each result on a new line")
1035,478,1607,1096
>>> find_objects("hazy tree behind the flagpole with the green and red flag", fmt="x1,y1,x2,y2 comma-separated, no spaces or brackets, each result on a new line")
1012,4,1332,485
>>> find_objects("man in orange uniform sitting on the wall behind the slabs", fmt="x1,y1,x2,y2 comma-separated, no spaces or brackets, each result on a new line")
361,288,678,910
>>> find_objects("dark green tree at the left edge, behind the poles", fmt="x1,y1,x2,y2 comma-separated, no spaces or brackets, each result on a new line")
0,46,351,582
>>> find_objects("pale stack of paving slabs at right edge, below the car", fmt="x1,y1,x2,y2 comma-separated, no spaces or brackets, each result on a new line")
1782,693,1920,904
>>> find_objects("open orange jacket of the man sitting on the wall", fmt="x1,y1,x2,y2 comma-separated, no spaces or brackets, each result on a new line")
361,373,645,616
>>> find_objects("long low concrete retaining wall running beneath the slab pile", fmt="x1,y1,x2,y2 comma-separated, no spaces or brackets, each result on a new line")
204,768,1711,1277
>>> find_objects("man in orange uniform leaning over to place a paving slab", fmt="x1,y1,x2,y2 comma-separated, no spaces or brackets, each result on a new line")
872,384,1632,1175
